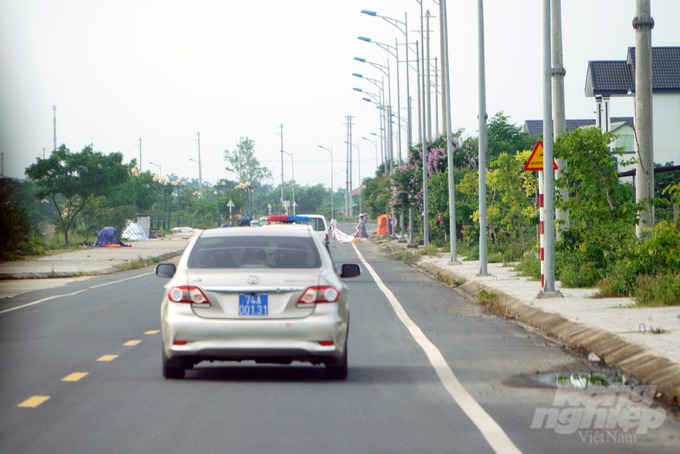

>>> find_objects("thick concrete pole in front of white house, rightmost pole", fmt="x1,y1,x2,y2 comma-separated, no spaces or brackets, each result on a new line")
633,0,654,237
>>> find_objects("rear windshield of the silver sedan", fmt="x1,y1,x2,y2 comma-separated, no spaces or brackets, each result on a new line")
188,236,321,268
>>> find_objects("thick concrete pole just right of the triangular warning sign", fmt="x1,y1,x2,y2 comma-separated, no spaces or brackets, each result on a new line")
543,0,569,238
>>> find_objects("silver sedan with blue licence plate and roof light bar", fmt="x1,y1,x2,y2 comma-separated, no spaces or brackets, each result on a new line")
156,225,360,380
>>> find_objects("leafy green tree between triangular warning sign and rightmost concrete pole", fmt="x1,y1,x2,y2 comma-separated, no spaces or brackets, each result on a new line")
554,128,639,286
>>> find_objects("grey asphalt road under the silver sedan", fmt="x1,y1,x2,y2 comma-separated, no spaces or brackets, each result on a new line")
0,234,680,454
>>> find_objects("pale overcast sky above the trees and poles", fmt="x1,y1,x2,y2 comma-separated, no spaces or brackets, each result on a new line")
0,0,680,192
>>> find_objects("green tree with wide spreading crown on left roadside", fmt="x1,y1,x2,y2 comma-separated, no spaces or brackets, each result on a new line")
25,145,129,245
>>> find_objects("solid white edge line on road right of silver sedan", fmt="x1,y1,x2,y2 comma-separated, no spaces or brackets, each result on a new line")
352,244,522,454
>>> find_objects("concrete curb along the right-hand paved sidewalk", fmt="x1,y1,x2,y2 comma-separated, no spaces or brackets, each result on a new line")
415,259,680,400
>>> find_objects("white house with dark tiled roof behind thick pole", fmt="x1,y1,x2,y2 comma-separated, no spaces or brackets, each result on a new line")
585,47,680,165
